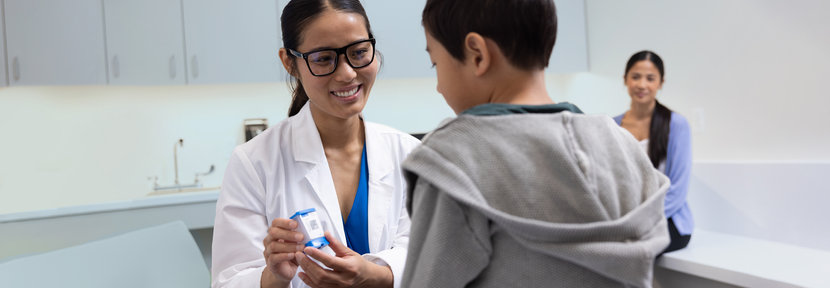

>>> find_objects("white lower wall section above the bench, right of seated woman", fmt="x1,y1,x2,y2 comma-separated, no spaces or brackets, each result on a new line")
688,162,830,251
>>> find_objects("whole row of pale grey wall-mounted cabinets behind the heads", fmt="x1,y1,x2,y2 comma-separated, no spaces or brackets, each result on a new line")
0,0,588,86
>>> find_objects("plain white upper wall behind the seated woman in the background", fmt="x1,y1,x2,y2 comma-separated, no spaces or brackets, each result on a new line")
549,0,830,161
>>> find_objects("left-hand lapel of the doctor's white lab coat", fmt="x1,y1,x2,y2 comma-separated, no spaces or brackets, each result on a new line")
291,103,346,245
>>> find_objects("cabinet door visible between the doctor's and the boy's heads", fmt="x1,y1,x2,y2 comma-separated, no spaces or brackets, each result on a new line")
361,0,435,79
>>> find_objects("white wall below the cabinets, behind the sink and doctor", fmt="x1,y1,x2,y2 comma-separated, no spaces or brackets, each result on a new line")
0,79,452,213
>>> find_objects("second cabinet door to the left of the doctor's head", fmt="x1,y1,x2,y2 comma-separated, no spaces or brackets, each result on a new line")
104,0,186,85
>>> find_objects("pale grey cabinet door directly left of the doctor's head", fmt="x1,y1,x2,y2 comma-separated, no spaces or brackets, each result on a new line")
183,0,284,84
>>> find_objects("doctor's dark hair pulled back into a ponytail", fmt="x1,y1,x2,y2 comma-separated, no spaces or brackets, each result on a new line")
280,0,374,117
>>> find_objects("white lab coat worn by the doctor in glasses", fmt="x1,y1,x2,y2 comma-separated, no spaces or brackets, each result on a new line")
211,104,420,287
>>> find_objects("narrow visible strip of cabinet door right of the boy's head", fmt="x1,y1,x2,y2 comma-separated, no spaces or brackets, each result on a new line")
546,0,588,73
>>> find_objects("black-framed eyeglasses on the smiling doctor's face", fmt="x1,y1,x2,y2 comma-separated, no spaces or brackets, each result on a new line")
288,38,375,77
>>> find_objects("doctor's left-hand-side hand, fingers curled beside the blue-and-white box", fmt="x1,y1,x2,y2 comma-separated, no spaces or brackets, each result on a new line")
260,218,304,287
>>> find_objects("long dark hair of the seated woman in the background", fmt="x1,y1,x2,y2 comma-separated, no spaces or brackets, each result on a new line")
625,50,672,168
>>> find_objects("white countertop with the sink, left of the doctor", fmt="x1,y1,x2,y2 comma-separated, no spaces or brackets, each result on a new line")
0,189,219,261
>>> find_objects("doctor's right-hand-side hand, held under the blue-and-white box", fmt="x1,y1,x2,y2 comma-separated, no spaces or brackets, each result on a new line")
296,232,394,288
